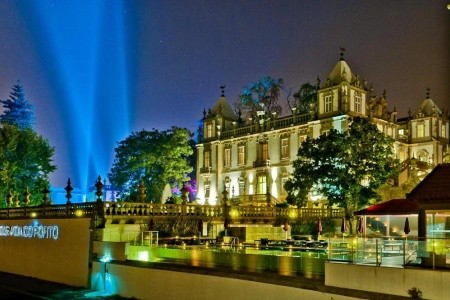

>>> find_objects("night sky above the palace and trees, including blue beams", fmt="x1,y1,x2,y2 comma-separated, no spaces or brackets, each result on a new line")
0,0,450,188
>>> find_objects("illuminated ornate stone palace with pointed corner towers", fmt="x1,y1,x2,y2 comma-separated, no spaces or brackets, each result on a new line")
197,57,449,205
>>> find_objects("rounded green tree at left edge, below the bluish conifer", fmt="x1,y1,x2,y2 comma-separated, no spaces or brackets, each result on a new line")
0,124,56,205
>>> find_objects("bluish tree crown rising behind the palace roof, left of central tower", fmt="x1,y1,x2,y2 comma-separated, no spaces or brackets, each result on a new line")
236,76,283,118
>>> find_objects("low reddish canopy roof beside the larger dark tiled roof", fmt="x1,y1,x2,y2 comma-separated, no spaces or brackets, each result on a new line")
355,199,419,216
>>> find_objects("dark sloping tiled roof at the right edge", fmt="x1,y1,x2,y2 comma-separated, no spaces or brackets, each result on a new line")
407,163,450,200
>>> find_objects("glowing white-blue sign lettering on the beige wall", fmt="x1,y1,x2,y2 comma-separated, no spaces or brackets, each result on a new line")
0,221,59,240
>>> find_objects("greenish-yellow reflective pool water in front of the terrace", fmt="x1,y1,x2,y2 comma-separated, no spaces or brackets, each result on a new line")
149,246,327,278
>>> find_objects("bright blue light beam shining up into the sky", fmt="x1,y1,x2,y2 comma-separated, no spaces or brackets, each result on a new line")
19,1,131,192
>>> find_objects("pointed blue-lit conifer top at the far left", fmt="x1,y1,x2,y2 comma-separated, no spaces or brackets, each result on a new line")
0,80,34,129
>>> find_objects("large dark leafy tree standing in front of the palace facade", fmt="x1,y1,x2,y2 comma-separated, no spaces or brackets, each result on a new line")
285,118,399,231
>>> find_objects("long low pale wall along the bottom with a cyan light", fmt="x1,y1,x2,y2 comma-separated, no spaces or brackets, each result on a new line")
91,262,356,300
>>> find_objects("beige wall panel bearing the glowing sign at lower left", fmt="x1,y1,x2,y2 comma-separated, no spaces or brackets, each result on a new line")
0,218,90,287
